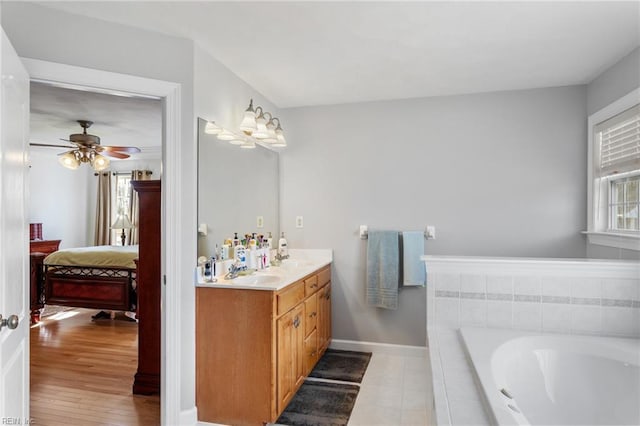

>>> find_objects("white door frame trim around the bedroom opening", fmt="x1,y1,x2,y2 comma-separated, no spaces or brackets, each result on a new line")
21,58,184,424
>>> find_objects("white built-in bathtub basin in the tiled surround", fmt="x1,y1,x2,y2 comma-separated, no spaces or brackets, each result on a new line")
460,328,640,425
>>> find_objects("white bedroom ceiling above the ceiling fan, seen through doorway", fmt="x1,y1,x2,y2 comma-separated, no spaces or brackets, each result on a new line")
29,82,162,153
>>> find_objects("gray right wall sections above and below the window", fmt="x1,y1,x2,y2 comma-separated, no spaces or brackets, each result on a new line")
587,47,640,260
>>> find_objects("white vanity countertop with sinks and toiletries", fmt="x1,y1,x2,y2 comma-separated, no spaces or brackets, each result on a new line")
196,249,333,291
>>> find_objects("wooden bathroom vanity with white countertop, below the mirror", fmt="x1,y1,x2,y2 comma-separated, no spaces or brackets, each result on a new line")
196,250,331,425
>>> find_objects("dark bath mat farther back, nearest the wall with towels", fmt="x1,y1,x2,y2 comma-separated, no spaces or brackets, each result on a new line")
309,349,371,383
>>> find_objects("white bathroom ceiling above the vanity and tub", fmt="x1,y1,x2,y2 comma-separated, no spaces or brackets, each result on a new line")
35,1,640,108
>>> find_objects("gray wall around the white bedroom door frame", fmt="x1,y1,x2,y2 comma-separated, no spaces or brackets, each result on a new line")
2,2,198,411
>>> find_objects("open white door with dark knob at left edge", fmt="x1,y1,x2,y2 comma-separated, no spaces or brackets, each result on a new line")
0,28,30,425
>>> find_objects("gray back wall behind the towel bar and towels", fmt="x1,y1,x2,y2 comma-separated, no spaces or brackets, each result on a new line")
280,86,587,345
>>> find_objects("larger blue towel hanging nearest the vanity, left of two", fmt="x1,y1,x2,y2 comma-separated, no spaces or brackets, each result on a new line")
367,231,400,309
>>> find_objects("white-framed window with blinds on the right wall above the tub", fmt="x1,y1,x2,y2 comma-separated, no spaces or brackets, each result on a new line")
587,89,640,250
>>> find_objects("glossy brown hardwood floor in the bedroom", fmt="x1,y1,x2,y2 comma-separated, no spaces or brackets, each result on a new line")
31,309,160,426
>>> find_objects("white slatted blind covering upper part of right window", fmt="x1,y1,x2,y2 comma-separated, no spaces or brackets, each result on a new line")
595,104,640,176
